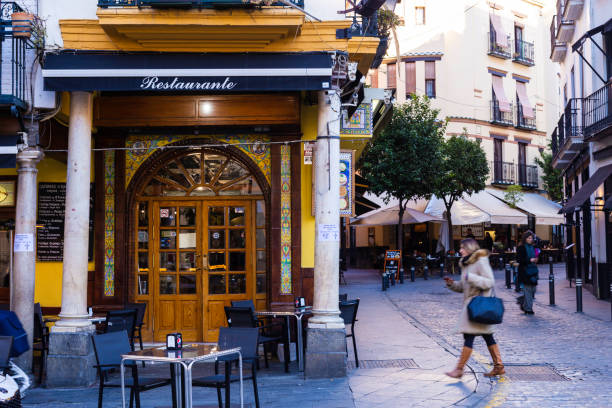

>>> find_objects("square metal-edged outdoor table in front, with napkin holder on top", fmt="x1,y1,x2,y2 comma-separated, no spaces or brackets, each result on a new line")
121,344,244,408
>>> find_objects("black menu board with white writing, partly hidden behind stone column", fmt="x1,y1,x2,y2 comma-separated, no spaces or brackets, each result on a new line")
36,183,94,262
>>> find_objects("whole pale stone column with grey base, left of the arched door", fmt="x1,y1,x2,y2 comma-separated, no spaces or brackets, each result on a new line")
47,92,95,387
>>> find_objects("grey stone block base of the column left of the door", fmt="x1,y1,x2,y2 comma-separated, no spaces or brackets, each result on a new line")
46,325,96,388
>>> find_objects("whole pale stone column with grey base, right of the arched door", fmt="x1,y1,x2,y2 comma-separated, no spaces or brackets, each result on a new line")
305,91,346,378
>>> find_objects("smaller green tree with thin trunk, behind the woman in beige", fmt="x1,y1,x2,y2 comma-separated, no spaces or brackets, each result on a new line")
433,129,489,249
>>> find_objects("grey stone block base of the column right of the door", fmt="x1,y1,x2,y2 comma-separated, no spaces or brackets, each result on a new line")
304,326,347,378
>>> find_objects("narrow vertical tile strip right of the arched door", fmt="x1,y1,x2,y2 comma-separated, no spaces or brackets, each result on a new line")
280,145,291,295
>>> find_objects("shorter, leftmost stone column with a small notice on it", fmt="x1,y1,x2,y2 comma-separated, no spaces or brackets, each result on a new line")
11,147,44,373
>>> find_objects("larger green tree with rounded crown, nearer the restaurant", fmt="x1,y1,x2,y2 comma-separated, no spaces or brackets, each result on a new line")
358,96,446,249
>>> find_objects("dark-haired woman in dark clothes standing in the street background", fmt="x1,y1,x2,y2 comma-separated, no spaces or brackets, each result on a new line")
516,231,538,315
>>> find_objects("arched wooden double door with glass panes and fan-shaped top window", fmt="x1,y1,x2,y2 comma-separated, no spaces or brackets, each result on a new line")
135,150,267,341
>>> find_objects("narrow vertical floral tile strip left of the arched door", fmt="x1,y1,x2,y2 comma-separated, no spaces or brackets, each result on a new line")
104,151,115,296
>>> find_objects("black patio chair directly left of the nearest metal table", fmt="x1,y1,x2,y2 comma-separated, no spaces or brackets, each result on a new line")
91,330,176,408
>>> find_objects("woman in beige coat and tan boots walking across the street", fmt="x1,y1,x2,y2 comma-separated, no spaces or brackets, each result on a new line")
444,238,506,378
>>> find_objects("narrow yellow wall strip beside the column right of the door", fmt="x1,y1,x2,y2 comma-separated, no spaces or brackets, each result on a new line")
301,101,318,268
